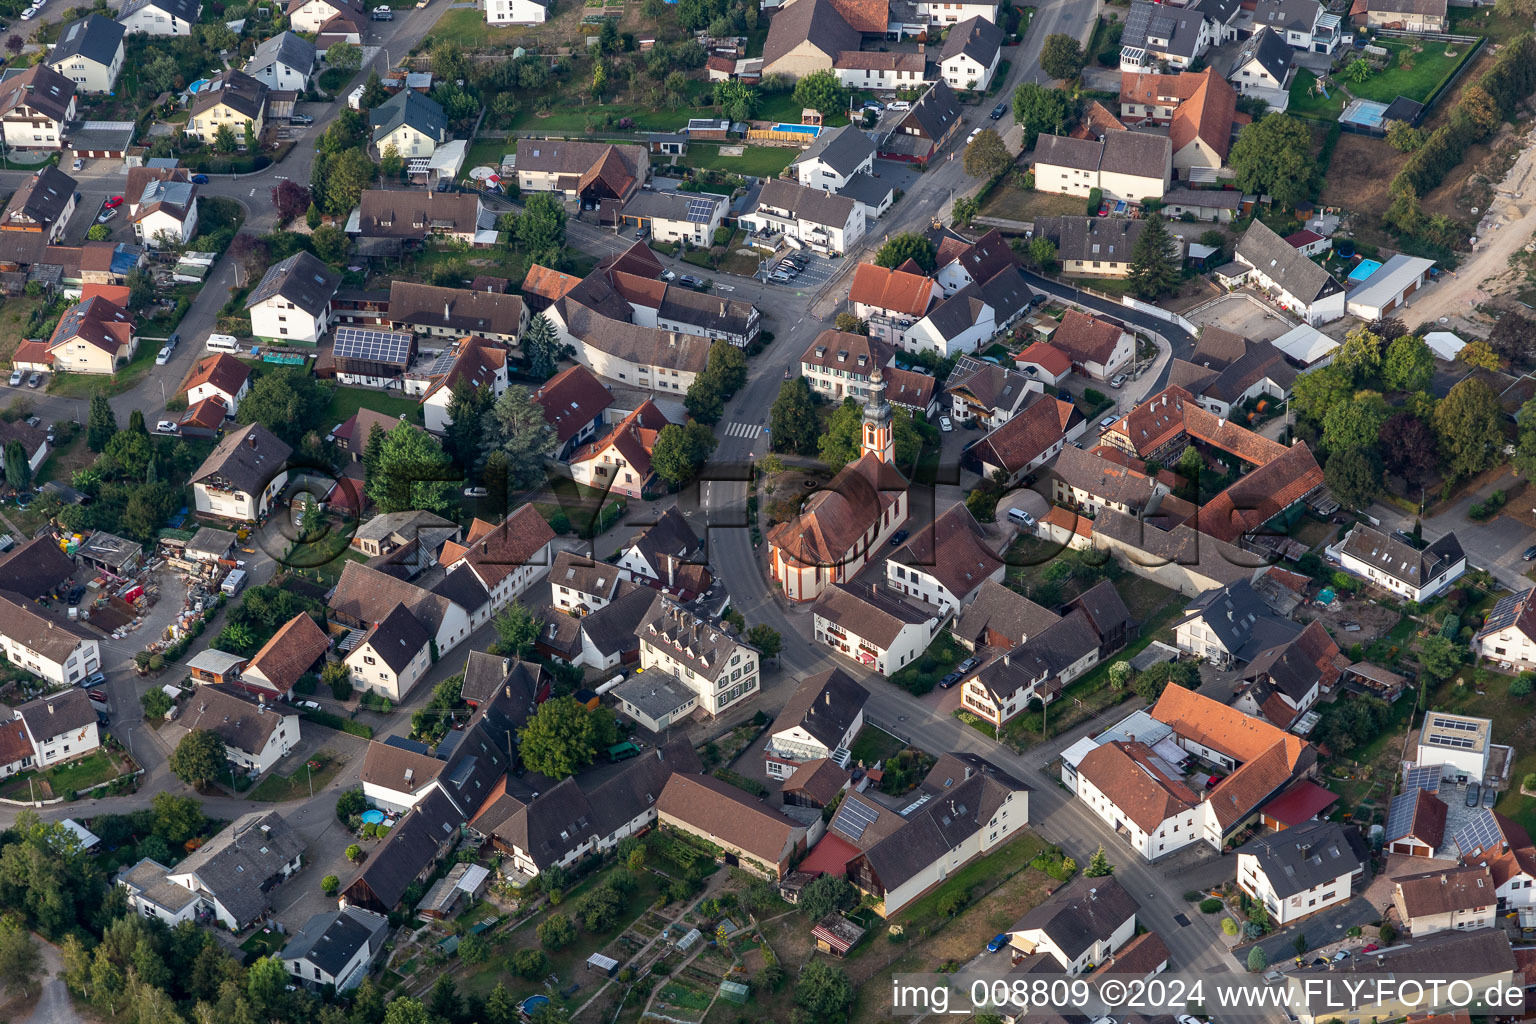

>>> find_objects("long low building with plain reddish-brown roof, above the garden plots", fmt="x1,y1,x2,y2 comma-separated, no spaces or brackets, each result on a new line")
656,776,814,881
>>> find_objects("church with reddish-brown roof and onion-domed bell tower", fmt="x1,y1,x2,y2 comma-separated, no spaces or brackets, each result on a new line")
768,367,909,602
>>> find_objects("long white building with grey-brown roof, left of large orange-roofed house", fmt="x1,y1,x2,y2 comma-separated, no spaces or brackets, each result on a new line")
1032,130,1174,203
